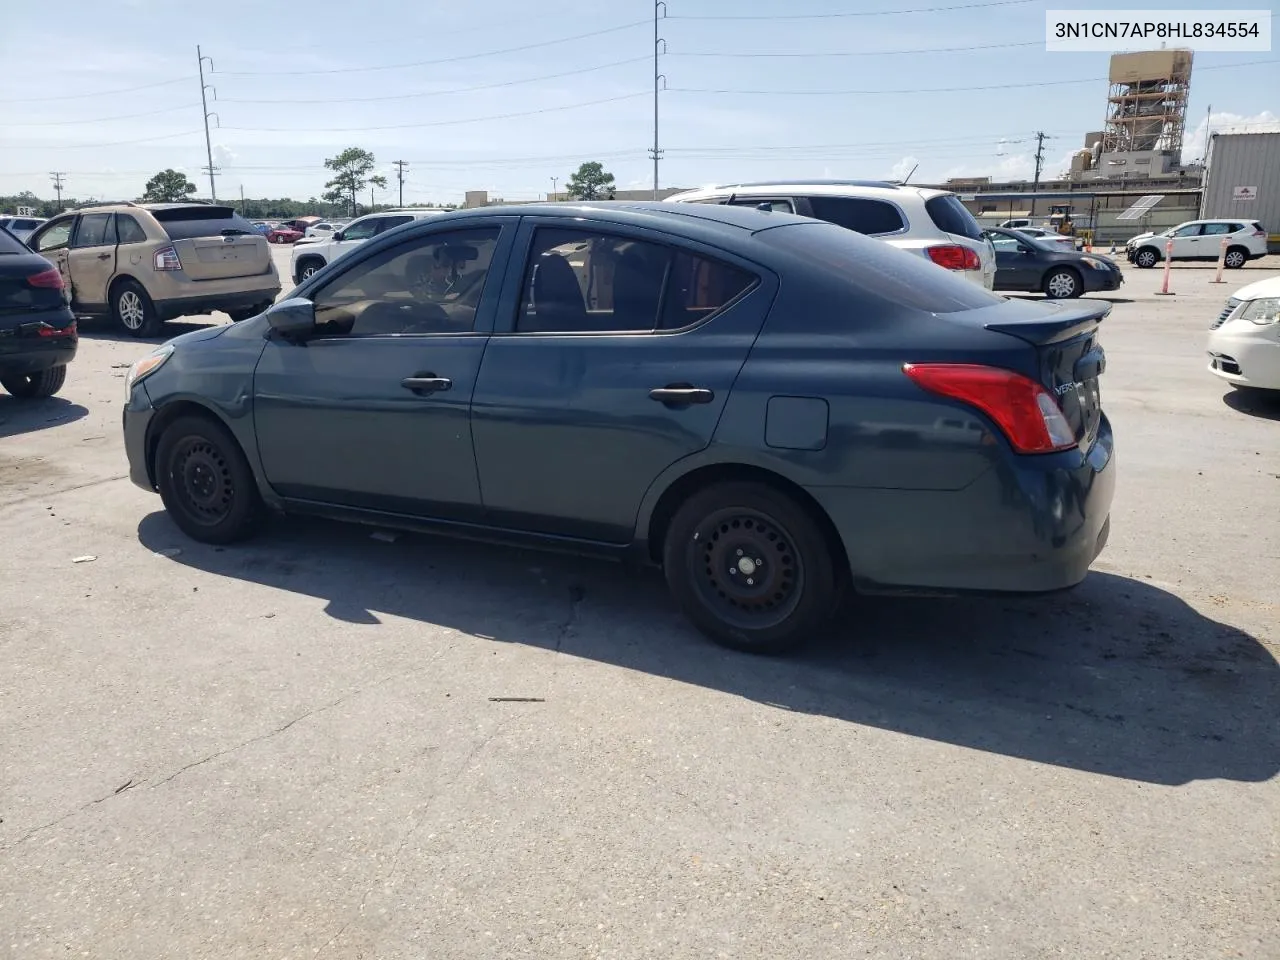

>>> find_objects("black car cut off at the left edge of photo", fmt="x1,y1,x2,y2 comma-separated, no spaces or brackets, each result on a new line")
0,228,79,398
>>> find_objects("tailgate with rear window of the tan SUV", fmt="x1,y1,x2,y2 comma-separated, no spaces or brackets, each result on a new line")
151,204,271,280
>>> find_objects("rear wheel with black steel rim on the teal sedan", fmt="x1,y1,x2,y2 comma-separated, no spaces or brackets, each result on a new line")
662,483,838,654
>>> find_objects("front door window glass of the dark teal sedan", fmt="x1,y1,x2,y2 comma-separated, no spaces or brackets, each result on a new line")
315,227,502,337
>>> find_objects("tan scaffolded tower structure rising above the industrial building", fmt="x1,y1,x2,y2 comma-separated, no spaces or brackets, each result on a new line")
1102,49,1192,156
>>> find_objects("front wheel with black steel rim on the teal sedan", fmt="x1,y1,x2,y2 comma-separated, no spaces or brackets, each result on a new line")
155,416,264,544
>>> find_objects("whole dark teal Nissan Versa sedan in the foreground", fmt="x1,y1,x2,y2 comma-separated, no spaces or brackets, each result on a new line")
124,204,1114,652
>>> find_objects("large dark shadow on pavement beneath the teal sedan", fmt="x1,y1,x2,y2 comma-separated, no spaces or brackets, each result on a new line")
138,512,1280,785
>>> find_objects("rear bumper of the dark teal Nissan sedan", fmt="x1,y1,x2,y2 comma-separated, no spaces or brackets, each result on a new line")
809,416,1115,593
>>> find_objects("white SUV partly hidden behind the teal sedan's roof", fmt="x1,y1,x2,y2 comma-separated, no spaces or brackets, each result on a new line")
667,180,996,291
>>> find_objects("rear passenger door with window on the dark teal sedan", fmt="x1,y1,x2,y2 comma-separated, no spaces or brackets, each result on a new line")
471,218,777,543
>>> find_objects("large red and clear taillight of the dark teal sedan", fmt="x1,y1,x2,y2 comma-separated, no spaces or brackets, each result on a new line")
902,364,1075,453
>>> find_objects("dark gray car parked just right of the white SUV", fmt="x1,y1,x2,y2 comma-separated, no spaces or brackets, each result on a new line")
987,227,1124,300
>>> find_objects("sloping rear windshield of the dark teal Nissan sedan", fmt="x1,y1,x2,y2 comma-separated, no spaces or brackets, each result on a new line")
756,221,1004,314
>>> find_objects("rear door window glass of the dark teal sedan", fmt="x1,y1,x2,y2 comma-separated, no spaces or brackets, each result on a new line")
516,228,755,333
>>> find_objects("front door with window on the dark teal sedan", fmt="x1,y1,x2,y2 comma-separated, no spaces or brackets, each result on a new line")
253,220,515,520
